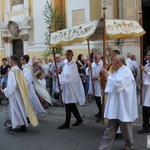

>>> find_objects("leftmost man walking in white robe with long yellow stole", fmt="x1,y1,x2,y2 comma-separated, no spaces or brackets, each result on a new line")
2,55,38,132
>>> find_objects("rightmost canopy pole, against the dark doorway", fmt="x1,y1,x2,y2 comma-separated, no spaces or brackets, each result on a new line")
139,11,143,105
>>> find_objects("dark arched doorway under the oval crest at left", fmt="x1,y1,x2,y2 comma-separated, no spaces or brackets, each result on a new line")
13,39,23,68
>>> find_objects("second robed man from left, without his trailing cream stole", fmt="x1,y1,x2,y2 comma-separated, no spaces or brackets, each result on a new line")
21,55,46,114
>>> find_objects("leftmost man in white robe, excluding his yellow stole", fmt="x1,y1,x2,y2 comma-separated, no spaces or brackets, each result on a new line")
2,55,28,132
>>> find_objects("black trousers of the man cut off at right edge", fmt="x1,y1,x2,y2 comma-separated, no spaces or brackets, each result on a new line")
142,106,150,130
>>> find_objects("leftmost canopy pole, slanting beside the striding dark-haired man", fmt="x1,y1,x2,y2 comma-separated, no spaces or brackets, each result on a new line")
53,48,64,107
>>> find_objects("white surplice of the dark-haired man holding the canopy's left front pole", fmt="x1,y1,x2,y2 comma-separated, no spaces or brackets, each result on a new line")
59,60,85,105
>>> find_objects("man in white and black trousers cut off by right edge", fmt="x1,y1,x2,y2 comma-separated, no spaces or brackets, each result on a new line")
138,51,150,134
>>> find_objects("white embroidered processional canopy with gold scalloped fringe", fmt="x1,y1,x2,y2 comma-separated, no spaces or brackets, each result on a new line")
50,19,145,48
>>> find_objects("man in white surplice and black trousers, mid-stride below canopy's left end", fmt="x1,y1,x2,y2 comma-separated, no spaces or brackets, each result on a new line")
56,50,85,129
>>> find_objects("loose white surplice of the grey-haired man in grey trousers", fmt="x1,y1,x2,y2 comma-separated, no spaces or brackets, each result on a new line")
104,66,138,122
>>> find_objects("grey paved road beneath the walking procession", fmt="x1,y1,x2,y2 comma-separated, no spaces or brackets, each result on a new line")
0,99,147,150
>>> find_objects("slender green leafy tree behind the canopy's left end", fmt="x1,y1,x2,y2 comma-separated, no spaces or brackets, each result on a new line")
43,1,66,57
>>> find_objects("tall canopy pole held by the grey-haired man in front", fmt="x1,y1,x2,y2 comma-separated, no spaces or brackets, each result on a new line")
101,6,107,124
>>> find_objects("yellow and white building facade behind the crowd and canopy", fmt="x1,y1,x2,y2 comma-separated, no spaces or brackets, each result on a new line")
0,0,150,61
